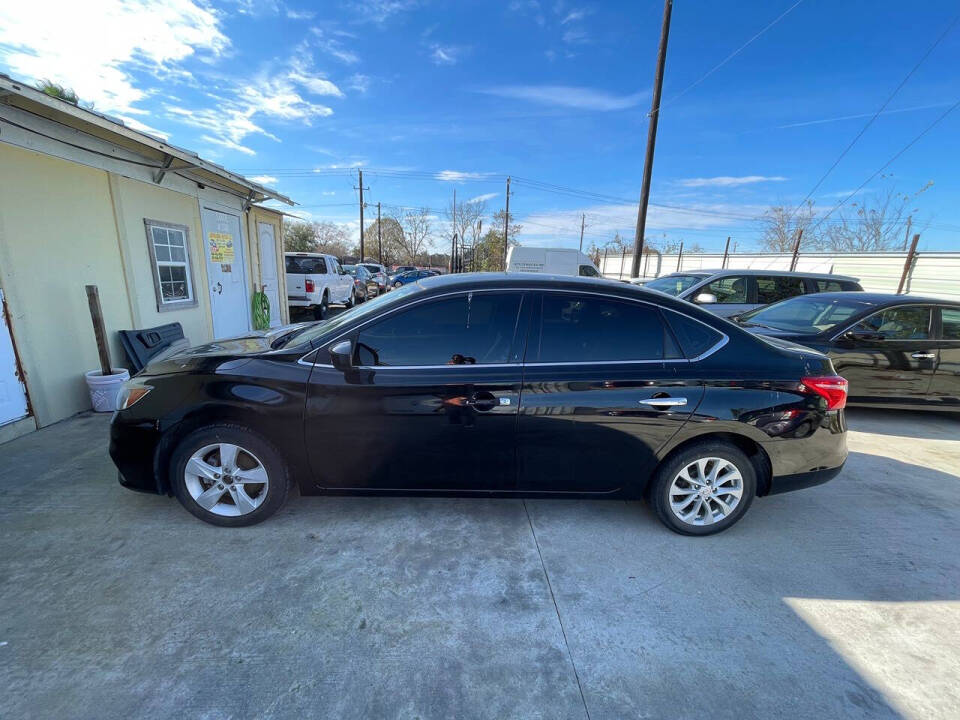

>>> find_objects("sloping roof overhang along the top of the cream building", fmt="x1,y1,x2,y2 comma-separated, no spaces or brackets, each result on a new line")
0,74,296,206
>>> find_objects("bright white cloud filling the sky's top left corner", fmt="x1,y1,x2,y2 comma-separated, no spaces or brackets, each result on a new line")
0,0,230,114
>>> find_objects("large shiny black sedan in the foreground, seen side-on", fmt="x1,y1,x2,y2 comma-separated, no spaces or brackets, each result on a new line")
110,273,847,535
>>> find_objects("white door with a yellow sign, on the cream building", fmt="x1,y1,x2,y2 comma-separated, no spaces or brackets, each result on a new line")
203,207,250,338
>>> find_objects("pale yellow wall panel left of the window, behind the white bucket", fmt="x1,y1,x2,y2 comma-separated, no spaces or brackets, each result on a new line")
0,145,133,426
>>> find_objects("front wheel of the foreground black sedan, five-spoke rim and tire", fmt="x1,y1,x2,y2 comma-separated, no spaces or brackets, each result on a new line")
170,425,289,527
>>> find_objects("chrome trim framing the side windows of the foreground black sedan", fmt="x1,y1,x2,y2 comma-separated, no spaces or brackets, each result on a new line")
297,287,730,370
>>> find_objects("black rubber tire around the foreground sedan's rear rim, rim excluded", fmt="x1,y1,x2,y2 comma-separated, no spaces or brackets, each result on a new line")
649,440,757,536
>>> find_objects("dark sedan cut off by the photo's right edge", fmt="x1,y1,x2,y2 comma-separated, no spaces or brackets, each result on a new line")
738,292,960,412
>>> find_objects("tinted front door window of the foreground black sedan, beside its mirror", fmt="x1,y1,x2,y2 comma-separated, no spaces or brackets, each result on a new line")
357,293,520,366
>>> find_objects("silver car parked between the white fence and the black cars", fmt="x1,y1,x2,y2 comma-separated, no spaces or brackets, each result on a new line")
643,270,863,317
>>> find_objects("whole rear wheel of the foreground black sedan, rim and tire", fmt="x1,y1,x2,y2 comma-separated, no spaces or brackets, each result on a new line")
650,440,757,535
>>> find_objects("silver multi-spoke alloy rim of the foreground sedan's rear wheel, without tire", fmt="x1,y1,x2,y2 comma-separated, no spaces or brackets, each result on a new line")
669,457,743,525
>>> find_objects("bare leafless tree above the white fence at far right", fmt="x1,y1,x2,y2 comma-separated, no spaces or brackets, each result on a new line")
822,182,933,252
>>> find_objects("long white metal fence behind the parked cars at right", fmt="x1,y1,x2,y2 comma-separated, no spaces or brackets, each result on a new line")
600,252,960,301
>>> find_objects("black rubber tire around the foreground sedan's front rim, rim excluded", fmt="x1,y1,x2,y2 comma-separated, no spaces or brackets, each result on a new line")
170,423,290,527
